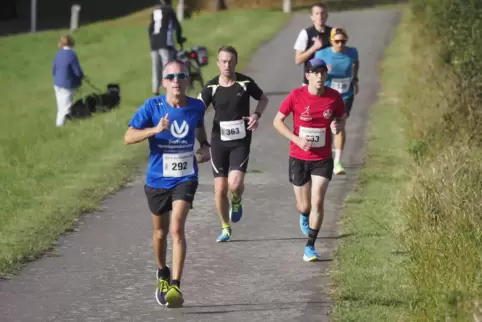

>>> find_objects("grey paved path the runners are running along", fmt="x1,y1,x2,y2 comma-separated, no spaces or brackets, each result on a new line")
0,11,398,322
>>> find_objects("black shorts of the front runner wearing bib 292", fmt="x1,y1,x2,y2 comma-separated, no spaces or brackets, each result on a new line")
144,180,198,216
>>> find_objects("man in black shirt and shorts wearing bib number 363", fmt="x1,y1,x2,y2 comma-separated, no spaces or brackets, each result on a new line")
198,46,268,242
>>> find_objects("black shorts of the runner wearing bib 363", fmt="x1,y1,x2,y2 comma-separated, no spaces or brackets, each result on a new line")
210,141,251,178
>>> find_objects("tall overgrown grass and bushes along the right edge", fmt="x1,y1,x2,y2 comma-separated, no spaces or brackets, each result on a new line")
403,0,482,321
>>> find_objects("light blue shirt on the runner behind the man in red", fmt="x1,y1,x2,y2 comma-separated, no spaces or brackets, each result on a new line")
315,46,358,101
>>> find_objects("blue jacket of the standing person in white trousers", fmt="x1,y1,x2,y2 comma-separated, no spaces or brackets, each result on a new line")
52,48,84,89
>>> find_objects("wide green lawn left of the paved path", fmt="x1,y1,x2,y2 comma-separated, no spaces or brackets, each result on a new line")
0,7,289,275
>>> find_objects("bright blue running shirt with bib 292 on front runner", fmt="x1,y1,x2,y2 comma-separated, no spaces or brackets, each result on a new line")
128,95,205,189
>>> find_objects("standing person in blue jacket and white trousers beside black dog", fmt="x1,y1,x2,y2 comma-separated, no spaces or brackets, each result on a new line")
52,35,84,126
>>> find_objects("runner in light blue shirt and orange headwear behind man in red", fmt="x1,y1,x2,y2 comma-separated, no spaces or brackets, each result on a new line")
315,27,359,174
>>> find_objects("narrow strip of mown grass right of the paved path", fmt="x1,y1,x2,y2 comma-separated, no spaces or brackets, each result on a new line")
333,6,410,322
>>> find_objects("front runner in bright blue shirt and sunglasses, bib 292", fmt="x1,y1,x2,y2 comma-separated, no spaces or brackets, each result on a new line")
124,60,210,307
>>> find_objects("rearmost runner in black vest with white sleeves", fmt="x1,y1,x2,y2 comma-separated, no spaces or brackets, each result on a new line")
294,3,332,85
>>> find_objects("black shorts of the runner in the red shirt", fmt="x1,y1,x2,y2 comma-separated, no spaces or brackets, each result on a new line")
288,157,333,187
